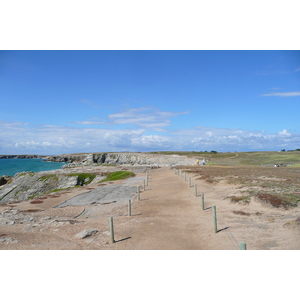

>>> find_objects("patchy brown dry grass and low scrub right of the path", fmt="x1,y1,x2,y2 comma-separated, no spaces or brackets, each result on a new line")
183,165,300,209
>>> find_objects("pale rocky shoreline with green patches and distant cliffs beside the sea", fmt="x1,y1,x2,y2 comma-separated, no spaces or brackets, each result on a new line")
0,153,195,204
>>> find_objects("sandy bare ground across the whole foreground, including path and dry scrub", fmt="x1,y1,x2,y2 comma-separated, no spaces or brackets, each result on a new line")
0,166,300,250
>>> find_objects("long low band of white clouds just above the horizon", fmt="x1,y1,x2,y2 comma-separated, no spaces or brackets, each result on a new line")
0,122,300,154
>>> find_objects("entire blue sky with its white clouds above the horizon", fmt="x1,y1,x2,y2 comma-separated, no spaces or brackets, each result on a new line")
0,50,300,154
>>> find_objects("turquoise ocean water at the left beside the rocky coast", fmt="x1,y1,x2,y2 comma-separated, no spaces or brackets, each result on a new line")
0,158,65,176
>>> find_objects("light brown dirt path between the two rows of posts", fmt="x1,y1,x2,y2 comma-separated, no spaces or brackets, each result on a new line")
104,168,235,250
